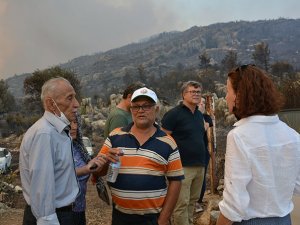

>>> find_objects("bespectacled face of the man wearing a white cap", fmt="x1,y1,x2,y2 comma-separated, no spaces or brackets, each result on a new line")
130,97,158,129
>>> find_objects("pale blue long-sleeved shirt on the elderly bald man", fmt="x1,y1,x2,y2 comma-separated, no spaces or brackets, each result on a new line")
20,111,79,225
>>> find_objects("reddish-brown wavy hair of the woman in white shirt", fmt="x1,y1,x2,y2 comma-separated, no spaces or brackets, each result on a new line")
228,65,284,118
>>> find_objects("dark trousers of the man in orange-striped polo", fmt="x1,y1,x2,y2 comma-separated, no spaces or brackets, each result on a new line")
111,208,159,225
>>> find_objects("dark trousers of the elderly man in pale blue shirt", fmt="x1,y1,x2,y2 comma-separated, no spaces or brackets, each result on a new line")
23,205,75,225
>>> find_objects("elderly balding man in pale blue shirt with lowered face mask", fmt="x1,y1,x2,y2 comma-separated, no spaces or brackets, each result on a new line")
20,78,105,225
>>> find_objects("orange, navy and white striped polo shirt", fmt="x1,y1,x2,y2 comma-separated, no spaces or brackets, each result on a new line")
99,124,184,215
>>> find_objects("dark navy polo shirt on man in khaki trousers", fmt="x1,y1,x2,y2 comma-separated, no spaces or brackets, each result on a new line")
161,104,206,166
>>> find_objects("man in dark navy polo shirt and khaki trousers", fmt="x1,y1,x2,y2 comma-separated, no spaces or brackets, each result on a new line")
162,81,206,225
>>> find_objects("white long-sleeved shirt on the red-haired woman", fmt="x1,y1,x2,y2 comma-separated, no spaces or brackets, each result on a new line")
219,115,300,222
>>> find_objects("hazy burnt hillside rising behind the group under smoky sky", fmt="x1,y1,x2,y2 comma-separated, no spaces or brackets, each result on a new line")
7,19,300,100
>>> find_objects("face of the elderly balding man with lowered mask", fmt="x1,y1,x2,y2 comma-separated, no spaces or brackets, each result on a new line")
55,82,79,121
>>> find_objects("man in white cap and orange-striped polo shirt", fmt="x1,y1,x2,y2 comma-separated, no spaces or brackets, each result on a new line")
94,87,184,225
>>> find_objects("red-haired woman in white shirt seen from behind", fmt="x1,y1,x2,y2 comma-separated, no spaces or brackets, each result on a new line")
217,65,300,225
